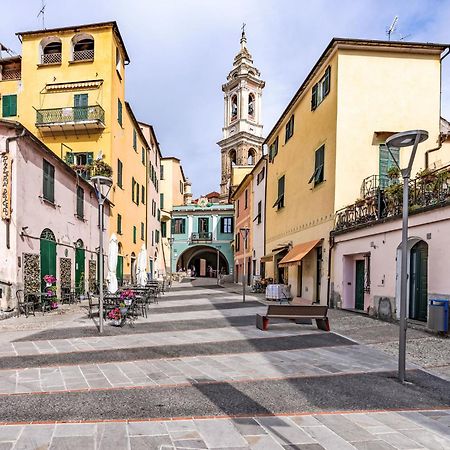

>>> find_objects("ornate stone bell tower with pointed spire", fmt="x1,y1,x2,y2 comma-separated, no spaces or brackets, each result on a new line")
217,24,265,203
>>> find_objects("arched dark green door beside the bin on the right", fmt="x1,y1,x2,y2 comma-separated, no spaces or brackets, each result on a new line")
409,241,428,322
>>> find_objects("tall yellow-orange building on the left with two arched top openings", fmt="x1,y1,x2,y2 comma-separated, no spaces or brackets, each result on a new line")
0,22,150,278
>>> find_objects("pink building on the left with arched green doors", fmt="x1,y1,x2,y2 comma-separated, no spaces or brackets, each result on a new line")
0,120,109,311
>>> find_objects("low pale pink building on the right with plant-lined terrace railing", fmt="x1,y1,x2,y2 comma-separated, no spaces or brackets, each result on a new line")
330,166,450,323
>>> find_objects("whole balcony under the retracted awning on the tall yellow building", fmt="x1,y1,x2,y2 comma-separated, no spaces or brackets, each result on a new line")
36,105,105,131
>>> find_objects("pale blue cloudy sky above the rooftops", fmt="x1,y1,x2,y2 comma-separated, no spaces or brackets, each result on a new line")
0,0,450,196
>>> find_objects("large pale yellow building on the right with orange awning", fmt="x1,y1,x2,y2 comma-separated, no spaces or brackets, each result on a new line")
264,39,450,303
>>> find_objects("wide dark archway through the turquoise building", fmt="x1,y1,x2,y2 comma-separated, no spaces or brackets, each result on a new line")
176,245,230,277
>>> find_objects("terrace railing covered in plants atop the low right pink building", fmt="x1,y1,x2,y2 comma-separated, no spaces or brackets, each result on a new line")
334,165,450,231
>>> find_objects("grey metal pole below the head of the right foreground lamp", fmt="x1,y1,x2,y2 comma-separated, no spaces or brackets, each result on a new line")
398,173,409,383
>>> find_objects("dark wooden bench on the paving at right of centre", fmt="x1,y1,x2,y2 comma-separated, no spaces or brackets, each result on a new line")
256,305,330,331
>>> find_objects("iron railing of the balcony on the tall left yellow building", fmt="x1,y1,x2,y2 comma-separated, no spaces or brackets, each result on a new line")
36,105,105,126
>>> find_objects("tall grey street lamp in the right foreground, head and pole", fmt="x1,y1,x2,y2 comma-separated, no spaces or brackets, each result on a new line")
386,130,428,383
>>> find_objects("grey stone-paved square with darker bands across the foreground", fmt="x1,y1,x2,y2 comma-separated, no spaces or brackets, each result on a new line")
0,284,450,450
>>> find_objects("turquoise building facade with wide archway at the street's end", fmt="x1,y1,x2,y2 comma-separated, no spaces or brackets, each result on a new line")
171,201,234,277
